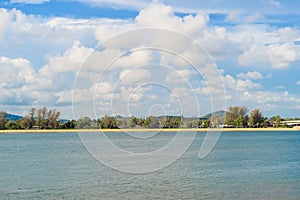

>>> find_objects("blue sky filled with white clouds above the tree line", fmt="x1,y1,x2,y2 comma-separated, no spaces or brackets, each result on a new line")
0,0,300,119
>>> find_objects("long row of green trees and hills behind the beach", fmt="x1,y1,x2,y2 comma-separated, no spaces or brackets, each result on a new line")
0,106,296,130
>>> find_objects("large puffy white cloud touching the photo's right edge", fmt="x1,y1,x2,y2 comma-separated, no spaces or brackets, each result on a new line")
228,24,300,69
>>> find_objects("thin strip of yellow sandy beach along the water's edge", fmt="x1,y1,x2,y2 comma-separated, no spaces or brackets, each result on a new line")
0,127,300,134
